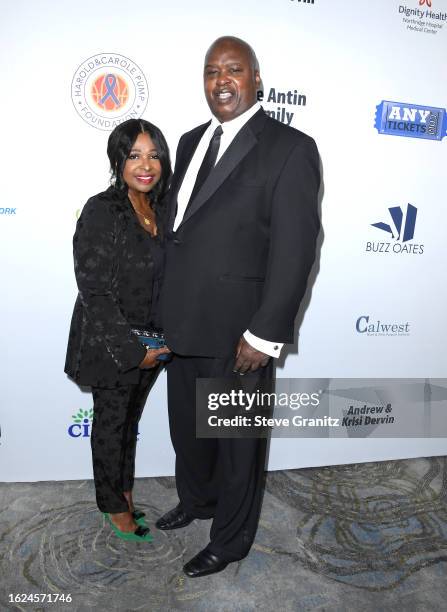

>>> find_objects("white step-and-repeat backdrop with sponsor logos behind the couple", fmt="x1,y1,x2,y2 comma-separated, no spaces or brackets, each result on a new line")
0,0,447,481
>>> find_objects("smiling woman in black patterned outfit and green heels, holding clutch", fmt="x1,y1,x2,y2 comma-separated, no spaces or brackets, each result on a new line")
65,119,171,541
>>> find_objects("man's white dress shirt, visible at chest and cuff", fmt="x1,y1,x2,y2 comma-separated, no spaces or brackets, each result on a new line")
174,102,283,357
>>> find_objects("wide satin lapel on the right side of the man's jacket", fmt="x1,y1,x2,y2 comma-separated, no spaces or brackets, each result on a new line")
178,109,267,229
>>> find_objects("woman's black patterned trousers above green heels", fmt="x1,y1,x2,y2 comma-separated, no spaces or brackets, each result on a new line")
91,367,160,514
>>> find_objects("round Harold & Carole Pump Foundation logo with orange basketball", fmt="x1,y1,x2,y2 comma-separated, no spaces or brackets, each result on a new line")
71,53,148,131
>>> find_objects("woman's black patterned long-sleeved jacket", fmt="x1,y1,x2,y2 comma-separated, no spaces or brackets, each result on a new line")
65,187,164,387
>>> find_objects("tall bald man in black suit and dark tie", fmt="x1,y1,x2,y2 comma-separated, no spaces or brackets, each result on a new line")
157,36,320,577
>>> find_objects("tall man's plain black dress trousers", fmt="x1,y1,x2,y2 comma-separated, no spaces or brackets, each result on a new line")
167,354,273,561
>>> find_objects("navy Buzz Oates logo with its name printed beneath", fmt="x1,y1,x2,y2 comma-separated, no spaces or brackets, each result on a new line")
365,204,424,255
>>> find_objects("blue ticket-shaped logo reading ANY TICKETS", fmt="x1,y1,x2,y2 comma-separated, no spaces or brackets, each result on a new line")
374,100,447,140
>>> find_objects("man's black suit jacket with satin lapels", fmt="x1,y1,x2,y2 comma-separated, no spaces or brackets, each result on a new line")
161,109,320,357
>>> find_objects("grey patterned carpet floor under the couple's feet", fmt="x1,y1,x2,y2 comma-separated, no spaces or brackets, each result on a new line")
0,457,447,612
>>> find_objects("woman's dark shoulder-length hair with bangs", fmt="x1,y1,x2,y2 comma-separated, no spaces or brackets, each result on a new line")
107,119,172,208
